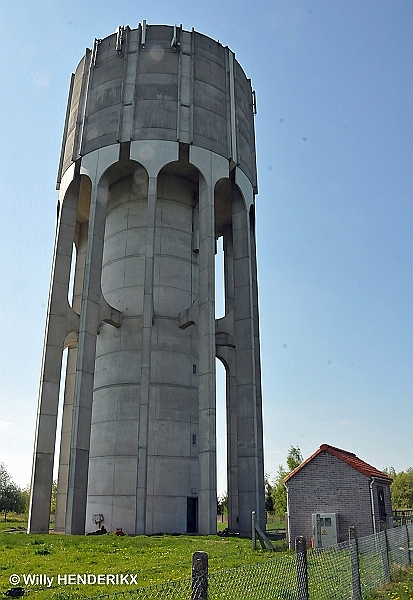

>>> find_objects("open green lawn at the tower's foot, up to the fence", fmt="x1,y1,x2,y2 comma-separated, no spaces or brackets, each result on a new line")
0,522,284,600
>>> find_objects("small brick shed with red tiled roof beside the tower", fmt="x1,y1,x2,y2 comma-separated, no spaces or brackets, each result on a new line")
284,444,393,548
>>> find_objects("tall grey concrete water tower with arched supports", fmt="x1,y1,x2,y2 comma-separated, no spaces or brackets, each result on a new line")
29,21,265,534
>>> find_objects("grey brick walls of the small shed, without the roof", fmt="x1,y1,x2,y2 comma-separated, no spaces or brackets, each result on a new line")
288,451,391,547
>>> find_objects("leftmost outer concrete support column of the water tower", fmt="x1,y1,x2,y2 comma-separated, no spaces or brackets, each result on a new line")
28,182,78,533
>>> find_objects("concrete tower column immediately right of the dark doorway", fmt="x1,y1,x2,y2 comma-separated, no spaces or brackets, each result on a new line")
198,170,217,535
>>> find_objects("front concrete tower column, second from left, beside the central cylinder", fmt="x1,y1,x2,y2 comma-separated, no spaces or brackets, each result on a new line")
66,177,108,534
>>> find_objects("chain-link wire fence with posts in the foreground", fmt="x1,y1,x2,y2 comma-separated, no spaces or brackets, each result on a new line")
61,523,413,600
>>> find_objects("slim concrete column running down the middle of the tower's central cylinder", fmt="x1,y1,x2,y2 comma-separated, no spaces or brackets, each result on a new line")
135,177,157,534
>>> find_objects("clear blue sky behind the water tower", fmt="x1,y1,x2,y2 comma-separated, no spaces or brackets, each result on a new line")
0,0,413,491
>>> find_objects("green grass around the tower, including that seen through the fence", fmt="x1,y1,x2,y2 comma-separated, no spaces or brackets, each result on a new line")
5,521,413,600
